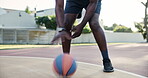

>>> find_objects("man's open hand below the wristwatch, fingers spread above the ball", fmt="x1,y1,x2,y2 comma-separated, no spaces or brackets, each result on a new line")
51,31,72,43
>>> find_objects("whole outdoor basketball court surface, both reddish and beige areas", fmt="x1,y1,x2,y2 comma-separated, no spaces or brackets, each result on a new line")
0,43,148,78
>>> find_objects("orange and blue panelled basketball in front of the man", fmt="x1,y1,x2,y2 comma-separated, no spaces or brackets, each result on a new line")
53,54,77,76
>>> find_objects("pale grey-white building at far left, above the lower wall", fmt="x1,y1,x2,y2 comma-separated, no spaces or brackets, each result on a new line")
0,8,37,29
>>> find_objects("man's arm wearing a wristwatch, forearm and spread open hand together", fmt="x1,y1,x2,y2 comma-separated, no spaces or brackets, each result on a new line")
51,0,72,44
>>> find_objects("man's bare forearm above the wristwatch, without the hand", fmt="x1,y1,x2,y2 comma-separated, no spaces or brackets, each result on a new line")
55,0,64,27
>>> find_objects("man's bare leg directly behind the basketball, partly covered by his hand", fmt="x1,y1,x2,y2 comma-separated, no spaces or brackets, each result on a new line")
62,14,77,53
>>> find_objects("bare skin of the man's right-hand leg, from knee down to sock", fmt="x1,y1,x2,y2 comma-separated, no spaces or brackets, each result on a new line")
89,13,109,59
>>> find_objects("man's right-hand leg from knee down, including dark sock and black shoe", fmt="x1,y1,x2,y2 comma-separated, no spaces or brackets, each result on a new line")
89,13,113,72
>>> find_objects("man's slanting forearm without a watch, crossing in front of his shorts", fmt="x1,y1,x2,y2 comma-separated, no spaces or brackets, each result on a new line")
80,0,98,28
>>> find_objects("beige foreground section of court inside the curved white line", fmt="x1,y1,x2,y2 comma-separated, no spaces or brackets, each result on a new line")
0,56,144,78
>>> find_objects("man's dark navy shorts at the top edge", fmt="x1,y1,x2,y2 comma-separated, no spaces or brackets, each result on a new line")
65,0,101,14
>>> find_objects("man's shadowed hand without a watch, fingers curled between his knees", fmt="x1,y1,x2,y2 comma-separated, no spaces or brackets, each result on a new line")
72,24,83,38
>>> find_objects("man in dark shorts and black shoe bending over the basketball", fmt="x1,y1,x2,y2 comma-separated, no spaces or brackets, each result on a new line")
52,0,114,72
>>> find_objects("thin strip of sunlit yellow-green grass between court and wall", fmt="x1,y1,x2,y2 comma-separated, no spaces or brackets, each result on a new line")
0,43,127,50
